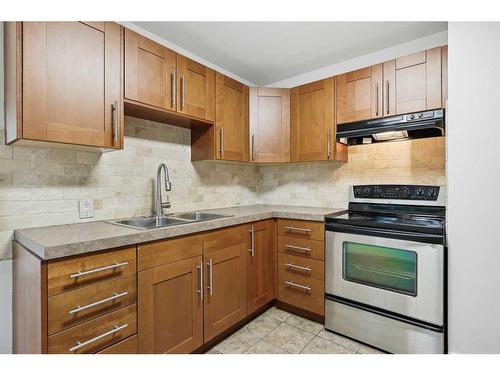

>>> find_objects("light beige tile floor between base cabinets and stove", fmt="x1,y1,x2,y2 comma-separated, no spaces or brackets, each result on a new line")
207,307,382,354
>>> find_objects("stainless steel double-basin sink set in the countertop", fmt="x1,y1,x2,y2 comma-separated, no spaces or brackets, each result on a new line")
108,211,233,229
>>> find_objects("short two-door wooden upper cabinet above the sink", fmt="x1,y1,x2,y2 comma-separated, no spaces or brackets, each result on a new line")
125,29,215,127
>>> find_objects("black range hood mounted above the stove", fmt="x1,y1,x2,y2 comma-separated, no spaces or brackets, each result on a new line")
337,109,445,145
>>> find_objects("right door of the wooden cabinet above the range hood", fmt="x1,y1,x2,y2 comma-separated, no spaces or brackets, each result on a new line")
392,47,442,114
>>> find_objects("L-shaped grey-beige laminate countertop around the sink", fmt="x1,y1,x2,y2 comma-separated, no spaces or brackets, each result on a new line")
14,205,344,260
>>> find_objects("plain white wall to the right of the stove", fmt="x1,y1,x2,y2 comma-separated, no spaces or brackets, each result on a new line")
447,22,500,353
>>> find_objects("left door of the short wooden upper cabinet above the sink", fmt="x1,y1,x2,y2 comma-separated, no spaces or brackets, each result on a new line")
125,29,176,111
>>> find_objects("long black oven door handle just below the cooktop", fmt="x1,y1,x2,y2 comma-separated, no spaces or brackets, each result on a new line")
325,223,444,245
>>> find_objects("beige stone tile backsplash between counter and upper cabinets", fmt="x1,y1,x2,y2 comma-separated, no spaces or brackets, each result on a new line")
0,117,445,259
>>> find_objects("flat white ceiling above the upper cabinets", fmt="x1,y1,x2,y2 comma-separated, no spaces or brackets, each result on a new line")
133,22,448,86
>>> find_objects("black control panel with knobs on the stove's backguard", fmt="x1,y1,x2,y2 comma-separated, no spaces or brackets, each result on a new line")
352,185,440,201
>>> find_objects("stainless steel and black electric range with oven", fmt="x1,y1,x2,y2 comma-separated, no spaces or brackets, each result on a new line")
325,185,446,353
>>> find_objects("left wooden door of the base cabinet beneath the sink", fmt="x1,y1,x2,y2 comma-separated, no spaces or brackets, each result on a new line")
138,256,203,353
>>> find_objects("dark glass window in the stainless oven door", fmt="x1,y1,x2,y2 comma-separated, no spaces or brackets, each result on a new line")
342,242,417,296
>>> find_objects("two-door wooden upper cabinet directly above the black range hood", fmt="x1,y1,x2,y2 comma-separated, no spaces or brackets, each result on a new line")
336,47,447,124
